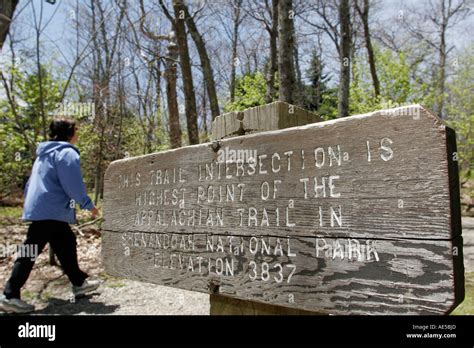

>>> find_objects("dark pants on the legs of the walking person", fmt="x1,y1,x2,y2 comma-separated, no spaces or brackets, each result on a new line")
3,220,87,298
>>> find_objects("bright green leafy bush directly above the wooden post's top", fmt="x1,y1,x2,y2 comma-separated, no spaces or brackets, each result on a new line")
224,72,267,112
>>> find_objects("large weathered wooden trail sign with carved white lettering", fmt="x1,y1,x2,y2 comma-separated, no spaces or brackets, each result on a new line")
102,105,464,314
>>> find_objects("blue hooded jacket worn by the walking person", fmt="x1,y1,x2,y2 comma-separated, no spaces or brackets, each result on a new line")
23,141,94,224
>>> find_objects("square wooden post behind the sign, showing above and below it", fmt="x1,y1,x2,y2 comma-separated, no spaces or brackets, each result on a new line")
210,101,322,315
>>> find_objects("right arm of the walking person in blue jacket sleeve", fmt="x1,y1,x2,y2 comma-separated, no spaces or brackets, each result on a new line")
56,148,96,209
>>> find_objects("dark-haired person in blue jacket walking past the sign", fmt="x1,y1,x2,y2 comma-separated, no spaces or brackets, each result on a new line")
0,119,100,313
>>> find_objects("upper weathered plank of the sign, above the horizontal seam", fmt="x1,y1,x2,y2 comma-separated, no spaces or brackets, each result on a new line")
104,109,460,239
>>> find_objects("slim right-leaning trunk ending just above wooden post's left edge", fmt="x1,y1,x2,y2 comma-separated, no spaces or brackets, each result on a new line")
184,5,220,120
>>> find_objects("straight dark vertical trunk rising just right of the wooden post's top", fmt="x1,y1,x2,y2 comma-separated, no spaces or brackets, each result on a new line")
337,0,351,117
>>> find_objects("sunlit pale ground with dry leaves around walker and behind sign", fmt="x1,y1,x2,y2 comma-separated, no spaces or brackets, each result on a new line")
0,207,474,315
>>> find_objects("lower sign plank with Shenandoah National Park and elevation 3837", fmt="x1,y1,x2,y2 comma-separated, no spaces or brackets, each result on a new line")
103,231,462,314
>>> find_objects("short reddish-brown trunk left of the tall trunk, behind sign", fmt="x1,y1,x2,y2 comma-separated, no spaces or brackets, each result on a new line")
166,32,181,149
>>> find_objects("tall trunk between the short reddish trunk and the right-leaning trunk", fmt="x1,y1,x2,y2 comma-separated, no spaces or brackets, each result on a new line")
173,0,199,145
